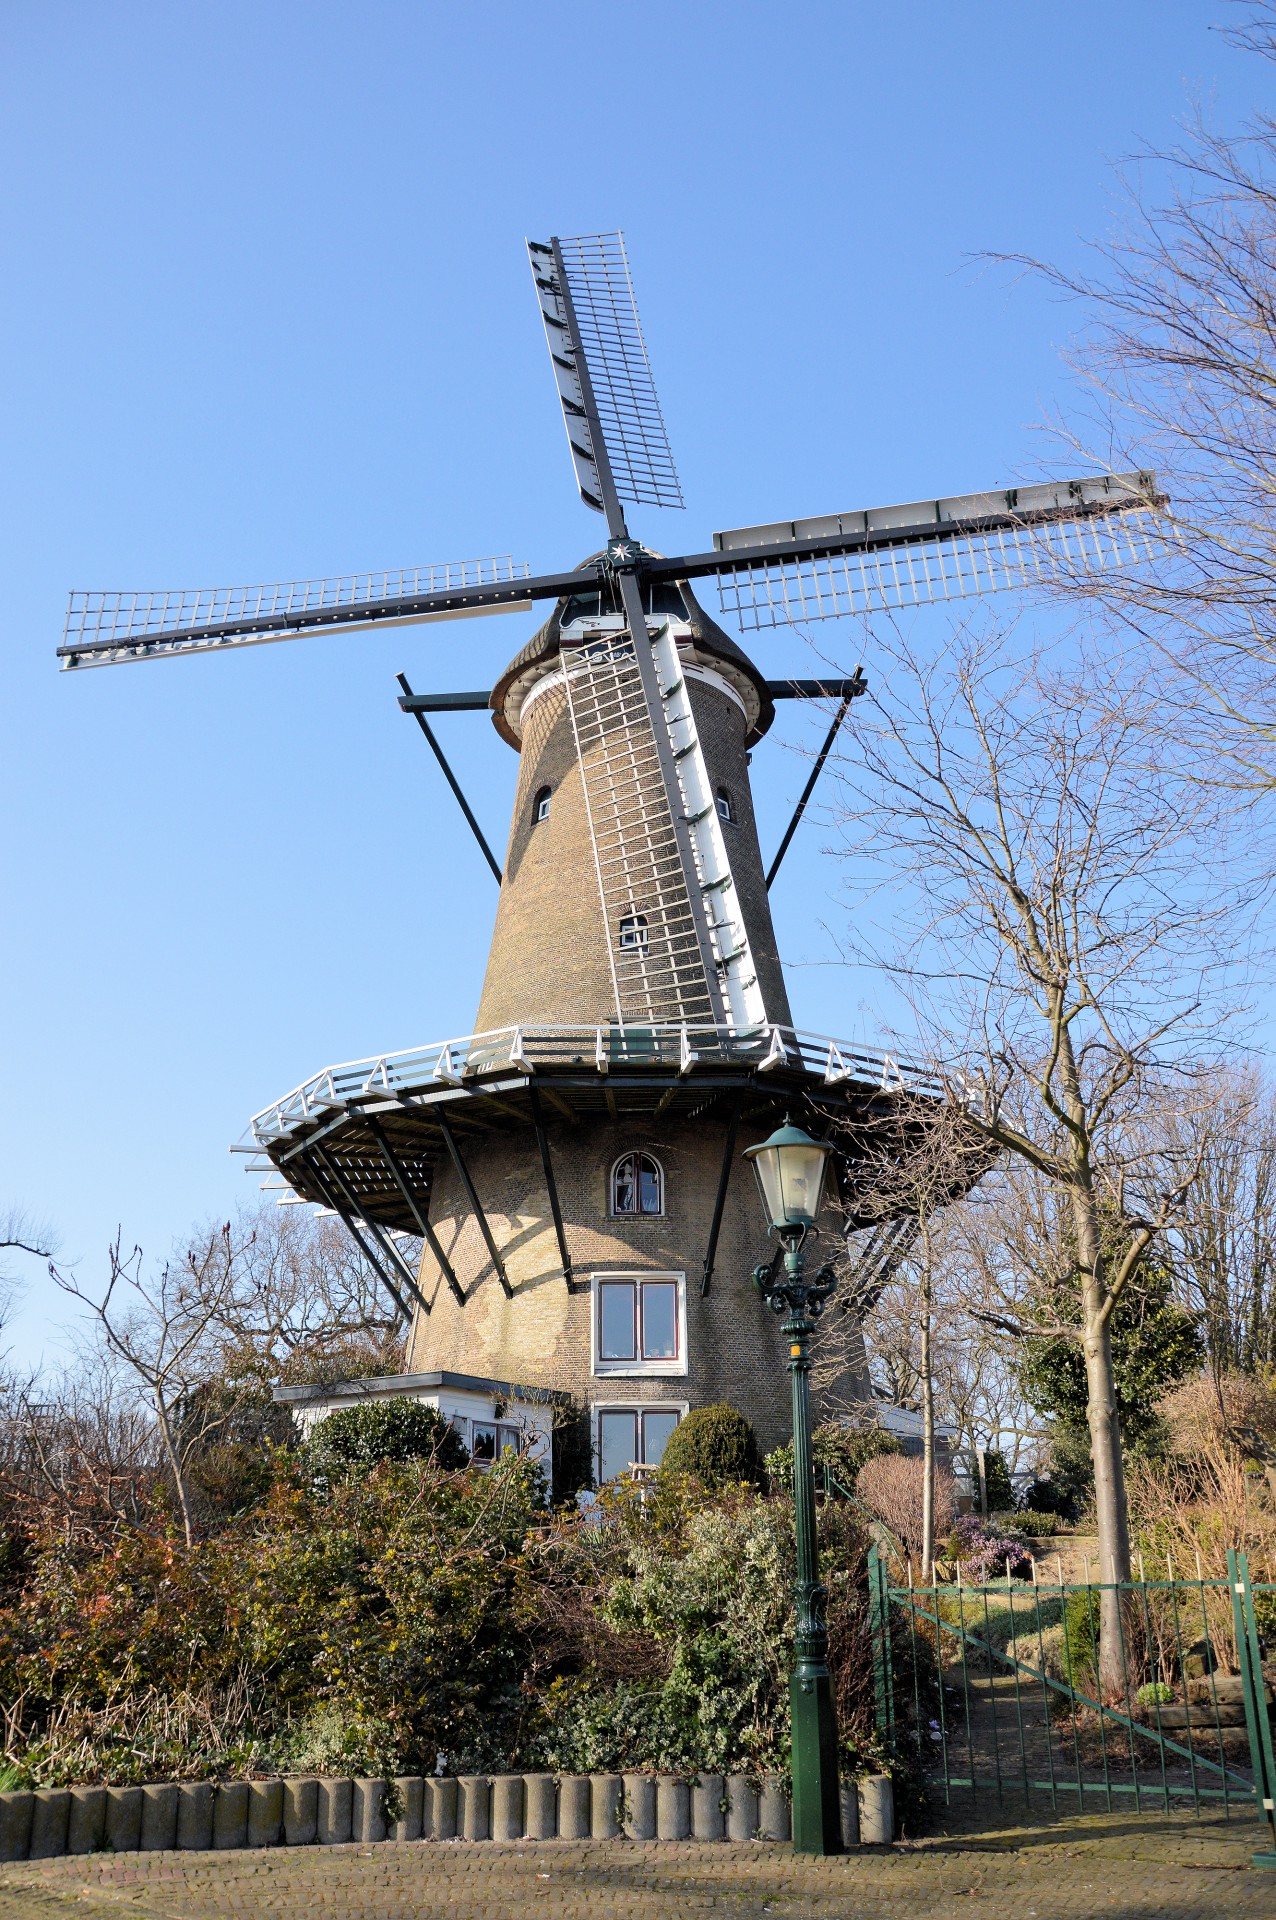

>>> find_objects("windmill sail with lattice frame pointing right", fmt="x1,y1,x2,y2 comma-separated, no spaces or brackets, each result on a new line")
643,472,1167,628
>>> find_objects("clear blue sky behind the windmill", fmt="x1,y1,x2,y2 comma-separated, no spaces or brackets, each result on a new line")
0,0,1270,1361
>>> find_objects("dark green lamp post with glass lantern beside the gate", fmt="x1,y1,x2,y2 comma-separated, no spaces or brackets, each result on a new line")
744,1121,842,1853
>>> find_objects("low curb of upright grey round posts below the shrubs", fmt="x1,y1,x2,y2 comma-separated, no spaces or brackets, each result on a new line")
0,1774,894,1862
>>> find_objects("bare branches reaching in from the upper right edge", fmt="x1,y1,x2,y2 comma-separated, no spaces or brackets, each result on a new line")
1017,0,1276,793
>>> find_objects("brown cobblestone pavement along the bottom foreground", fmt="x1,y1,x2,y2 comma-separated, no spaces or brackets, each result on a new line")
0,1814,1276,1920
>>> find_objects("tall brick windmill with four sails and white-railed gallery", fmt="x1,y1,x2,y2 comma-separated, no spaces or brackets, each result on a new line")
59,232,1163,1476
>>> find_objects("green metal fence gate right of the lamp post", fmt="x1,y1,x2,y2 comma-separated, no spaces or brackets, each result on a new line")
869,1548,1276,1866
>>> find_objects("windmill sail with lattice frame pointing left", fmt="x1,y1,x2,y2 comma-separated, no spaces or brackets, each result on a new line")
58,557,581,670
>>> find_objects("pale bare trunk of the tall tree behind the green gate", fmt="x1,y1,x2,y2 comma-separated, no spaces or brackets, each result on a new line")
1073,1187,1130,1699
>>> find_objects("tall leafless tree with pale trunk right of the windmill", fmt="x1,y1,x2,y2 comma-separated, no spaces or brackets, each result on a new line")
825,630,1253,1682
